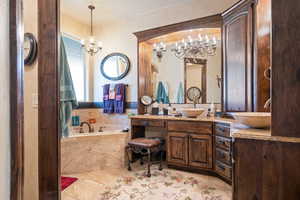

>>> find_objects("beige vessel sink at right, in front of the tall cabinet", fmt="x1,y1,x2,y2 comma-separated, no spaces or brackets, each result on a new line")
231,112,271,128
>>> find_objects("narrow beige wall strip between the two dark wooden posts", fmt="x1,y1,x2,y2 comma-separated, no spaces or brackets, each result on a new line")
23,0,38,200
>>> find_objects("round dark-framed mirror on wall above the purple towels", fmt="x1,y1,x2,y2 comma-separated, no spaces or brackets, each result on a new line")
100,53,130,81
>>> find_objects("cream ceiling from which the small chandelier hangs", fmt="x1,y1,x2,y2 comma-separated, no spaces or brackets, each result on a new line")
61,0,238,24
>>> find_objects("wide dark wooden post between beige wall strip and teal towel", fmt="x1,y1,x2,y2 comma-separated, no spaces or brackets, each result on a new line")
38,0,61,200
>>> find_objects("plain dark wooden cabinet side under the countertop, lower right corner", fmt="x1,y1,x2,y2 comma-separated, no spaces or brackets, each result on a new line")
233,138,300,200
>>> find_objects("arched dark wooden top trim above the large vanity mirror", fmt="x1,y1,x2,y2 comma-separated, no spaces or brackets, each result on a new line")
133,14,222,42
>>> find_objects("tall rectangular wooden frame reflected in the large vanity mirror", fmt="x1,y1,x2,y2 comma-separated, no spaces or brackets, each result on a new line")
184,58,207,104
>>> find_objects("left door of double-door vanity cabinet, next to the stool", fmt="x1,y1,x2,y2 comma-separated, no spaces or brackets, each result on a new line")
167,132,188,166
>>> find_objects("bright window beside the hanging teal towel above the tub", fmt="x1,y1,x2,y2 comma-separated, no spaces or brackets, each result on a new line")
63,35,87,101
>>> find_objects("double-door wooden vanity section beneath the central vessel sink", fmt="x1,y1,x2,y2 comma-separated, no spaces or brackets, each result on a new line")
167,121,213,169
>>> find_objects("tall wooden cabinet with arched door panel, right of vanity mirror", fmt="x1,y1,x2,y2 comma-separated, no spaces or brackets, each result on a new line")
222,0,271,112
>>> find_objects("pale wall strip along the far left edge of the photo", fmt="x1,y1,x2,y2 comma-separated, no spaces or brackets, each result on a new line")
0,0,10,200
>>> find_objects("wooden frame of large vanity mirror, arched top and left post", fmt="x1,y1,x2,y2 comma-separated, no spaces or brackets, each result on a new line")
134,14,223,114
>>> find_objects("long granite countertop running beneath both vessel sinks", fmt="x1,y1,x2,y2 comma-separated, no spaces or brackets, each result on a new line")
130,115,300,143
